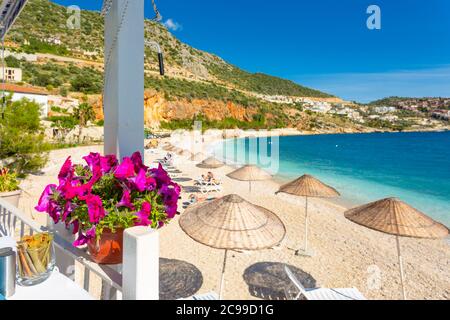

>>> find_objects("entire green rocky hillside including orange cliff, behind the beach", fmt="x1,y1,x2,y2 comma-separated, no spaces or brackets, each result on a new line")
5,0,448,132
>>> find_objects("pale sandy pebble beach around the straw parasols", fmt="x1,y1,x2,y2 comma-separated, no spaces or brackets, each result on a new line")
20,146,450,299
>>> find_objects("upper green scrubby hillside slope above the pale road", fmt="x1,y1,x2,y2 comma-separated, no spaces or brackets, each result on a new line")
8,0,329,97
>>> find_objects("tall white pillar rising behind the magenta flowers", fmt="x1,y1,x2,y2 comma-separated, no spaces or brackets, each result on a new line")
104,0,144,159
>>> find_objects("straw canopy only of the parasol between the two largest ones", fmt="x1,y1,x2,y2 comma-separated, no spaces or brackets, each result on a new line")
277,174,340,198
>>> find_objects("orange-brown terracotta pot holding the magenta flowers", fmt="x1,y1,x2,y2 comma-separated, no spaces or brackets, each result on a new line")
88,228,123,264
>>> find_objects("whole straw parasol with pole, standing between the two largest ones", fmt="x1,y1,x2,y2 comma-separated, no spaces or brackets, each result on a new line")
276,174,340,256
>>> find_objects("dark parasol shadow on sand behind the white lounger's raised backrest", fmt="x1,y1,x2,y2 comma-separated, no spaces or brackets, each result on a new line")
243,262,316,300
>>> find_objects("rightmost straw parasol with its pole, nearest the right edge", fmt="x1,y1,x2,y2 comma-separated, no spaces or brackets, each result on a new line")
345,198,449,299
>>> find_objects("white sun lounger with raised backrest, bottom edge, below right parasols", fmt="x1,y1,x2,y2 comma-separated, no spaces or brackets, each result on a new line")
284,266,366,300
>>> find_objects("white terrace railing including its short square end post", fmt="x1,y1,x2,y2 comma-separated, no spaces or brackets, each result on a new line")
0,198,159,300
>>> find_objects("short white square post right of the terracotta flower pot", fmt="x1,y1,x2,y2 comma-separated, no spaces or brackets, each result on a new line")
122,227,159,300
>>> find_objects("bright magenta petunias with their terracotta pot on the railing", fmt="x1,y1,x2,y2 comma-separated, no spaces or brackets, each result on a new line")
36,152,180,264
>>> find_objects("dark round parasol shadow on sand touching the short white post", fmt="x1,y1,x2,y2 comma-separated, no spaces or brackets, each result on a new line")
159,258,203,300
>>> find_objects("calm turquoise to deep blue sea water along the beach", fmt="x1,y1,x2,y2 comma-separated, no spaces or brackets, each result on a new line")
215,132,450,226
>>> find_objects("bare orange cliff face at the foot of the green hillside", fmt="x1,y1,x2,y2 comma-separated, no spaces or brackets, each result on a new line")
90,90,257,128
